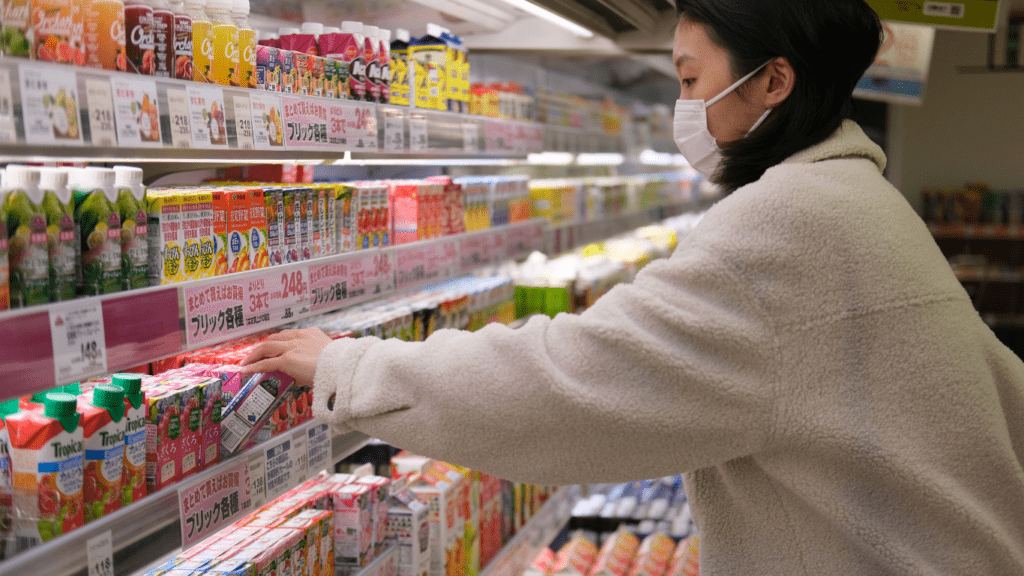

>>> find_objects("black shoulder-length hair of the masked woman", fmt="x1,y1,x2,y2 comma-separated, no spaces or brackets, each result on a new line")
676,0,882,193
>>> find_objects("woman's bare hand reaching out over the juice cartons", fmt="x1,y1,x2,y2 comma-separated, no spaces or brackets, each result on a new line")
242,328,332,387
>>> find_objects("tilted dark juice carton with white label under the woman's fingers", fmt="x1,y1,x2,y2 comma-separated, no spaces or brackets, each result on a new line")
220,372,295,454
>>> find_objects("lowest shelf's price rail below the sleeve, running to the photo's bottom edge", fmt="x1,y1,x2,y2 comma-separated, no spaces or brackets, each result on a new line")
479,486,582,576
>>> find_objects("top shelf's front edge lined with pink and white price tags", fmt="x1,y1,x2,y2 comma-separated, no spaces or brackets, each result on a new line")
0,57,626,164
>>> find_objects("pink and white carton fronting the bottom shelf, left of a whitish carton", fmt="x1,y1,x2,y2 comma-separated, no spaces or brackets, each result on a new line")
332,484,373,567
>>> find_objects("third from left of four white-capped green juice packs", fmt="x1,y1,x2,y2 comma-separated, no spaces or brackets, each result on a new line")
71,168,122,296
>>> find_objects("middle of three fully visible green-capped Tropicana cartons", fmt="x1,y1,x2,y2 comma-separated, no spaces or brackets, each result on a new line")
80,384,125,522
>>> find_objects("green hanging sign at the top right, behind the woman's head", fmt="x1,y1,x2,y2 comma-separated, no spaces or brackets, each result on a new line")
867,0,999,33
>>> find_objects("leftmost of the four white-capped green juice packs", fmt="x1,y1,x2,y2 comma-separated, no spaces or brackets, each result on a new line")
0,166,50,307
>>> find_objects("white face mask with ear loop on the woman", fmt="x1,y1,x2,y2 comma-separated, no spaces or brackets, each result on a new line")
672,60,771,178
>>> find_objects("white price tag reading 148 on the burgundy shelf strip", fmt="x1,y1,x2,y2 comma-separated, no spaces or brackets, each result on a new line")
49,300,106,382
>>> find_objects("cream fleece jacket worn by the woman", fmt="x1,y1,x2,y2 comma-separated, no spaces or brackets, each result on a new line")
313,122,1024,576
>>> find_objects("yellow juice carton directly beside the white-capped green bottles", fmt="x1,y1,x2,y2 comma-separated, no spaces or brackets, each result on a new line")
146,190,184,286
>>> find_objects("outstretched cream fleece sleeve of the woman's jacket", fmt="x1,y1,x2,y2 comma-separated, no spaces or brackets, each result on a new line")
313,246,777,485
